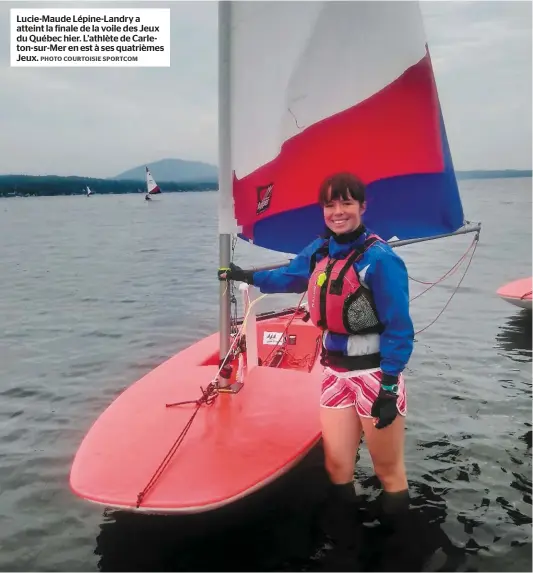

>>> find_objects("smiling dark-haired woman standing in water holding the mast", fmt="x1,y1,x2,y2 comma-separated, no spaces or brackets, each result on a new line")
218,173,414,547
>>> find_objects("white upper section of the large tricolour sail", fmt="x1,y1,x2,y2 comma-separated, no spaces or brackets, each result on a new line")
219,1,426,233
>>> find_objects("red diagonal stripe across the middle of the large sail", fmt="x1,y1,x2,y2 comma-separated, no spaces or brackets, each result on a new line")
233,53,444,227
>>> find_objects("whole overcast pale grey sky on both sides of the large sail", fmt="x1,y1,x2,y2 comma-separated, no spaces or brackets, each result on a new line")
0,0,532,177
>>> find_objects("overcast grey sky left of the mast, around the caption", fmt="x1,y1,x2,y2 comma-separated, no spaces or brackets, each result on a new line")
0,2,217,176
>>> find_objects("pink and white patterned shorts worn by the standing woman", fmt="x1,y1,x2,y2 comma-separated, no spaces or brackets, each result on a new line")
320,368,407,418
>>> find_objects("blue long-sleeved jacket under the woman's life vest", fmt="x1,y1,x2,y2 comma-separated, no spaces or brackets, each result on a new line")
253,231,414,376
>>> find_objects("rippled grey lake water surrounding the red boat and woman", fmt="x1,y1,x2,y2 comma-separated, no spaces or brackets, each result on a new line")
0,179,532,571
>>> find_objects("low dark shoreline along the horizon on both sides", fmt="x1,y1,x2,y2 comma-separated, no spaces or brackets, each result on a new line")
0,169,532,197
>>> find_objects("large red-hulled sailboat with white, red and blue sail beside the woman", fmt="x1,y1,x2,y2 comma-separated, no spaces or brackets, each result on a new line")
70,1,480,513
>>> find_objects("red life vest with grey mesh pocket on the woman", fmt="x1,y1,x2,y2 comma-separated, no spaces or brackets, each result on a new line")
307,235,383,334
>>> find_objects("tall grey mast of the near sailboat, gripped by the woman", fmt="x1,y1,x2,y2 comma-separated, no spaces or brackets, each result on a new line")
218,0,233,370
